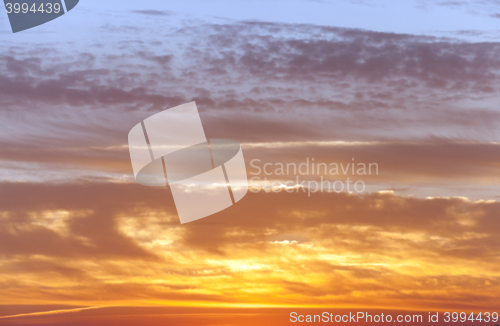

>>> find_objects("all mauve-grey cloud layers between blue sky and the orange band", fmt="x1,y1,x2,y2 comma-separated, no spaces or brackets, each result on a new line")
0,22,500,196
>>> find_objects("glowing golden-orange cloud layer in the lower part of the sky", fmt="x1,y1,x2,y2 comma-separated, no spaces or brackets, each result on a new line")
0,184,500,309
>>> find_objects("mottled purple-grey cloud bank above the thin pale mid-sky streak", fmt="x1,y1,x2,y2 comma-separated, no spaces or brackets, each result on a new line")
0,22,500,154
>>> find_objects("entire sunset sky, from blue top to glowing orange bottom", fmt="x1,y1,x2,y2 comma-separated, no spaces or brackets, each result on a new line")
0,0,500,325
